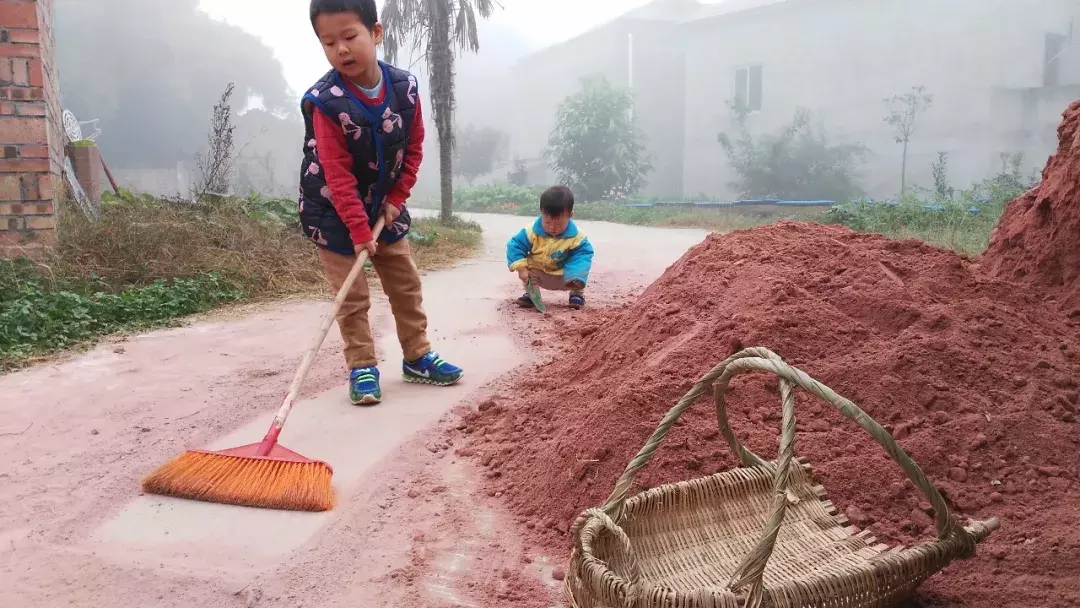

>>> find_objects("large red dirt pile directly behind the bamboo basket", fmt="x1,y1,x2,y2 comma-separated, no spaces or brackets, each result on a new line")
459,222,1080,607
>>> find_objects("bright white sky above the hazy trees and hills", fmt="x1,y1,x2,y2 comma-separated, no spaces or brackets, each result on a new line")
200,0,650,95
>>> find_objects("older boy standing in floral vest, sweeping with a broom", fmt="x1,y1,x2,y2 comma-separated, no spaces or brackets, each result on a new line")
299,0,462,405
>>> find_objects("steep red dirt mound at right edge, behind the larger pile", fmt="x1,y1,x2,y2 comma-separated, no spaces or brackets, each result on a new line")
981,102,1080,317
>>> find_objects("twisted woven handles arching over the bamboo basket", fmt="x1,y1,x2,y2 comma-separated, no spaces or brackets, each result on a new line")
603,348,975,606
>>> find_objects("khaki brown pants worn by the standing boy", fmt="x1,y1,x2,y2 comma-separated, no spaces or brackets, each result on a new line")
319,239,431,369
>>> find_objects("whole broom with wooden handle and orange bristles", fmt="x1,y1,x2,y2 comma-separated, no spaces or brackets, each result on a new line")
143,217,383,511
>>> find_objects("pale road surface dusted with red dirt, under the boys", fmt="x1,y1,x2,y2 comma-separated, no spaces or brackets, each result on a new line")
0,216,704,608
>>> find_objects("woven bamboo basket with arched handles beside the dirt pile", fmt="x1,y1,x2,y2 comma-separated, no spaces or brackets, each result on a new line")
566,348,998,608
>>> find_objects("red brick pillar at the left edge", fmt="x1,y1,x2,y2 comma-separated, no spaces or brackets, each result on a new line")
0,0,65,256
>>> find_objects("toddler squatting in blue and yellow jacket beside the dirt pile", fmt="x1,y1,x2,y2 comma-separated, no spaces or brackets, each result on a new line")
507,186,593,310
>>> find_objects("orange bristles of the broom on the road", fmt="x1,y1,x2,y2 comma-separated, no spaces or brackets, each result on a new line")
143,451,334,511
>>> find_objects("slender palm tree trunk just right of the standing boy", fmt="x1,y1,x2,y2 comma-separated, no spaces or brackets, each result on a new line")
428,2,454,224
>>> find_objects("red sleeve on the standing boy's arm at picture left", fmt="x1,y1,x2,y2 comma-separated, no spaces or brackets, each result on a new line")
314,109,375,245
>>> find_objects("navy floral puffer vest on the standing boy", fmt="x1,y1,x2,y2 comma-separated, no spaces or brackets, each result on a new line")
299,62,418,255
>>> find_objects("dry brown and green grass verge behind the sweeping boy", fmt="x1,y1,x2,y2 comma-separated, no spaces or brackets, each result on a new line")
0,193,482,373
